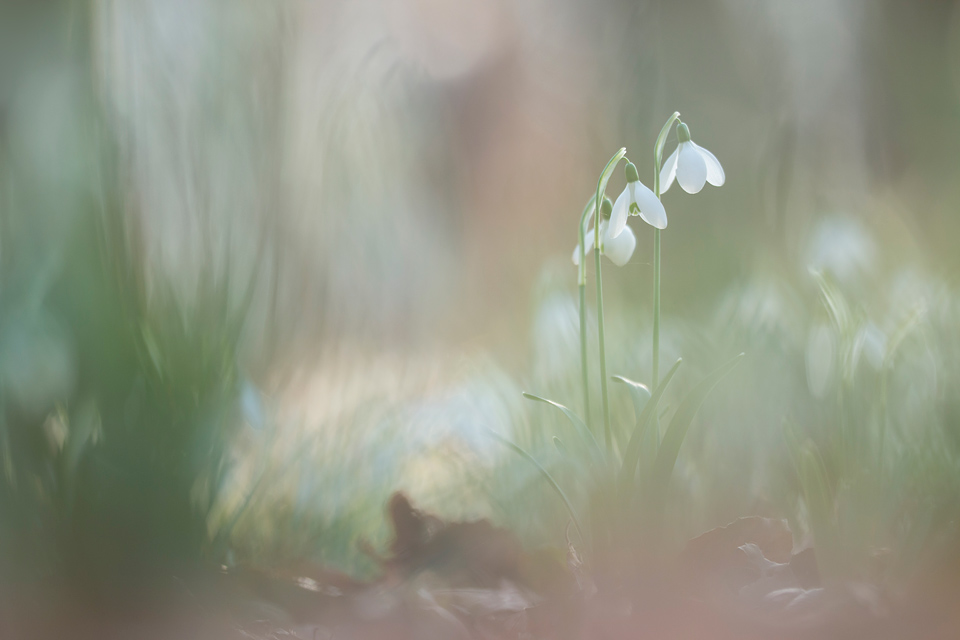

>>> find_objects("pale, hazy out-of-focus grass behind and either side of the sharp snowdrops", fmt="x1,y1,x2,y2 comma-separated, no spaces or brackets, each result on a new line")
216,212,960,580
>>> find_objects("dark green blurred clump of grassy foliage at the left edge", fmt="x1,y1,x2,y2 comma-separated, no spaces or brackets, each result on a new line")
0,199,255,595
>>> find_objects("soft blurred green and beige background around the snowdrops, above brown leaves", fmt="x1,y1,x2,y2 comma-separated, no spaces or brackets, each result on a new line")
0,0,960,608
